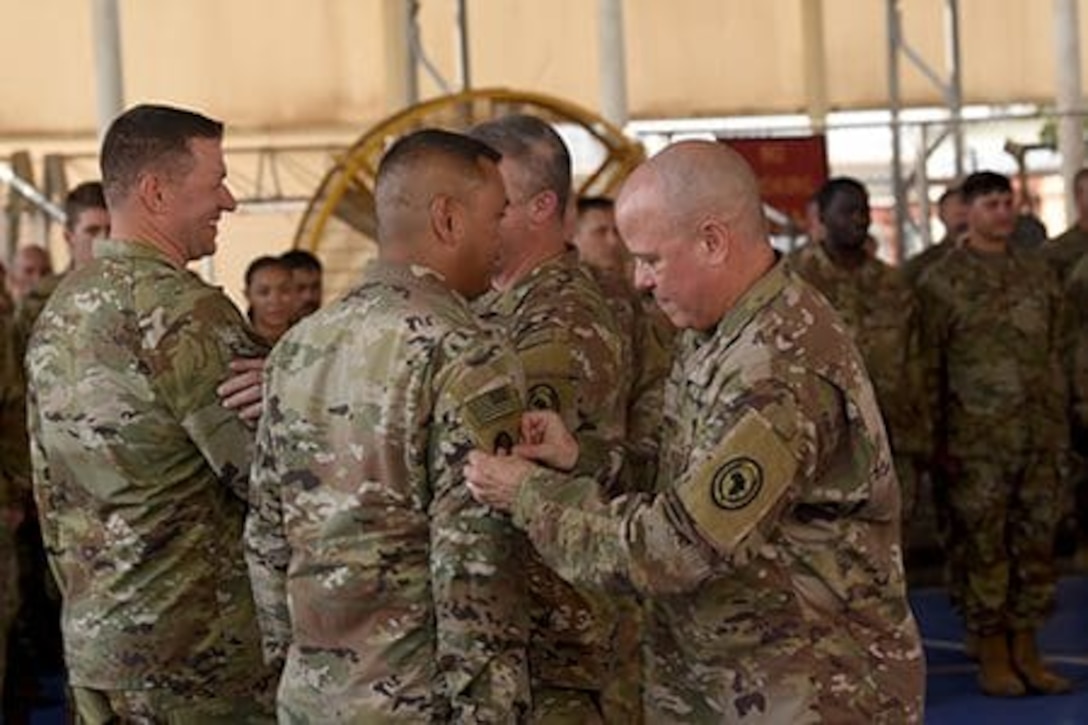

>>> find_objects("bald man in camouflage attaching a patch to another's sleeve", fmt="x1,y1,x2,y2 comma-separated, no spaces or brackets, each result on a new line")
466,142,925,723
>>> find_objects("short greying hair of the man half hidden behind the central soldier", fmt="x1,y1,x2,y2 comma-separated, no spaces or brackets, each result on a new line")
469,114,571,213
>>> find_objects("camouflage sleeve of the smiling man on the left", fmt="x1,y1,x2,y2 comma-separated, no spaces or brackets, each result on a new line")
149,287,268,501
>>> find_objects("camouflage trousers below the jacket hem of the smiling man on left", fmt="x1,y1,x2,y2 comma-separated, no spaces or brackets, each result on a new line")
72,687,275,725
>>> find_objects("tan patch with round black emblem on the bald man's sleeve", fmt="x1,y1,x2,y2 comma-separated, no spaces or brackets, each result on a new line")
677,410,798,555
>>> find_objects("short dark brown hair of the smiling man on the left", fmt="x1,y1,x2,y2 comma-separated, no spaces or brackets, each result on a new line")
99,105,223,204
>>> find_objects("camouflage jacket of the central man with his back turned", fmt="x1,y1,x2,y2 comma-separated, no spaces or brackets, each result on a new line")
246,261,529,723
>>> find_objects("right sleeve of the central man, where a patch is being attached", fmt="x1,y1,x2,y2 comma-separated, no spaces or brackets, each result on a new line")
430,341,529,723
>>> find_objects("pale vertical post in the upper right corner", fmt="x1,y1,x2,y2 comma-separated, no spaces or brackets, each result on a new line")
1054,0,1085,224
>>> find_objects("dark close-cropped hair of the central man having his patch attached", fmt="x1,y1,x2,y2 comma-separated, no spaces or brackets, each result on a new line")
374,128,502,247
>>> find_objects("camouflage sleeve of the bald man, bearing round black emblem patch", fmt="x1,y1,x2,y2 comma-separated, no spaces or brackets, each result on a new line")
514,381,818,595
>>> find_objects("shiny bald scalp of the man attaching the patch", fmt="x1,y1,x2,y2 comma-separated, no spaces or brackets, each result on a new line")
617,140,766,244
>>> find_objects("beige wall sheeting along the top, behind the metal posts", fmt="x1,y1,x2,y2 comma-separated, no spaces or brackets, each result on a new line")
0,0,1088,137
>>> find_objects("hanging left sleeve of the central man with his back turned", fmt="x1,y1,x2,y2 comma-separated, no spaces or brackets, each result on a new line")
245,372,292,663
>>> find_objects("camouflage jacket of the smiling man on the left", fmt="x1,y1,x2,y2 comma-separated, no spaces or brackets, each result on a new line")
26,241,267,697
